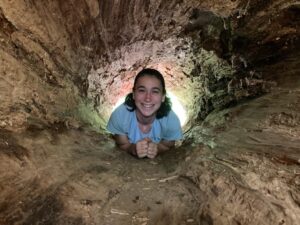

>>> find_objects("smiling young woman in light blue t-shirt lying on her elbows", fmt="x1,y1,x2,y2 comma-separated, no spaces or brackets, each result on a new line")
107,69,182,159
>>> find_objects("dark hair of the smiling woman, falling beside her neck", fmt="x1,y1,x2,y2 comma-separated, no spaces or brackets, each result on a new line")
124,68,172,119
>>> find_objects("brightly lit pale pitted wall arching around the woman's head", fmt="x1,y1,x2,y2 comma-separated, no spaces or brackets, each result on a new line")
88,38,239,130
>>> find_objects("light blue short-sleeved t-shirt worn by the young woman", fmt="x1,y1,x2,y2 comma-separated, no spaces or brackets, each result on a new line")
107,104,182,144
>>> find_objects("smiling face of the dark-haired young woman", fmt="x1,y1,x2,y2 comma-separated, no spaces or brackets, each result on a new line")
133,75,165,120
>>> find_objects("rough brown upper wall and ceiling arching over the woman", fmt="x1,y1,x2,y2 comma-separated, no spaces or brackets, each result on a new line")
0,0,299,130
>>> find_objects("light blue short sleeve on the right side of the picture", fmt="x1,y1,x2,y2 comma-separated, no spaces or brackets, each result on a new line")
162,111,182,141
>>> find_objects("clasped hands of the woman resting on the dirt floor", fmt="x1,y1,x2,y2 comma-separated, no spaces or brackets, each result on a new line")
136,138,158,159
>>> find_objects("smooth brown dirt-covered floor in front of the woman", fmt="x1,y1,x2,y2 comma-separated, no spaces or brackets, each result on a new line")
0,81,300,225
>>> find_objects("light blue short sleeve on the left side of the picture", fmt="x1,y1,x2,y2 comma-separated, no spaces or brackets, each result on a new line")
106,104,127,135
